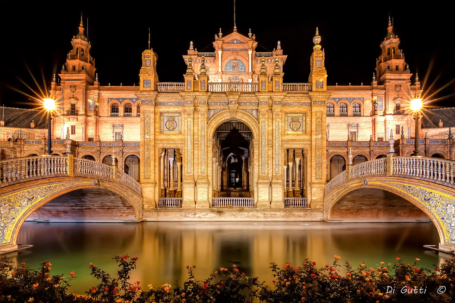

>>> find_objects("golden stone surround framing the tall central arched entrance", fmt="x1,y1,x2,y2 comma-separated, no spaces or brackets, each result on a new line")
207,110,259,204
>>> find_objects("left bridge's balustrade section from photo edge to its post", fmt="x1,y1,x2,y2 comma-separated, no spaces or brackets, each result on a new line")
0,156,68,187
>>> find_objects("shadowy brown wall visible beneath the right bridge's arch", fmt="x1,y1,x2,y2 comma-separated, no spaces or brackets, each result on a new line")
330,188,430,222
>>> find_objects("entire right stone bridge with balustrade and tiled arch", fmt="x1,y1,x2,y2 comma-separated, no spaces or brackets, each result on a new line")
324,154,455,250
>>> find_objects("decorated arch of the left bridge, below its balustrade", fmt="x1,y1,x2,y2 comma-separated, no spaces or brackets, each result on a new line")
0,177,142,250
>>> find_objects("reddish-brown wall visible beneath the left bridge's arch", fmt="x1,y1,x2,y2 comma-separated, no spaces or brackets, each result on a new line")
27,188,136,222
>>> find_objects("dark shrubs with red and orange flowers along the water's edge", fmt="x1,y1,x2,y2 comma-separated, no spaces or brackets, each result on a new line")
0,255,455,303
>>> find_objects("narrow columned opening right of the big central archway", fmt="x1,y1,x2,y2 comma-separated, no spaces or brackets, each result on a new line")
284,149,305,198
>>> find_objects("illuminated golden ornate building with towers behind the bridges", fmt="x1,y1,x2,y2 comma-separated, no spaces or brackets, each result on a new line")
1,16,453,209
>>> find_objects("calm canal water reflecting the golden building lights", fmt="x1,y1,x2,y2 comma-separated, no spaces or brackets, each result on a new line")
13,222,448,294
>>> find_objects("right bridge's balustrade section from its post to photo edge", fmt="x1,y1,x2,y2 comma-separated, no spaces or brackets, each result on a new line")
393,157,455,187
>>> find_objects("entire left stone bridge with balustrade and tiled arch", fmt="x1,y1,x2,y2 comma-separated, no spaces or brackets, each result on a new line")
0,155,143,251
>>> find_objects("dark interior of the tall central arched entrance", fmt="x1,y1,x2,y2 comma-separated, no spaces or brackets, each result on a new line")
213,121,253,197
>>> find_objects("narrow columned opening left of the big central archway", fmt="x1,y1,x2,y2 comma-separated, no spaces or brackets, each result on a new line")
160,148,182,198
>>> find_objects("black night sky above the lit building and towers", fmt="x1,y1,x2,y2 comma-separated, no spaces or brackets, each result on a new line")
0,0,455,107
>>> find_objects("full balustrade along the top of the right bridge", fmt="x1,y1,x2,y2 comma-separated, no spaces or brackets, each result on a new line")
324,156,455,196
